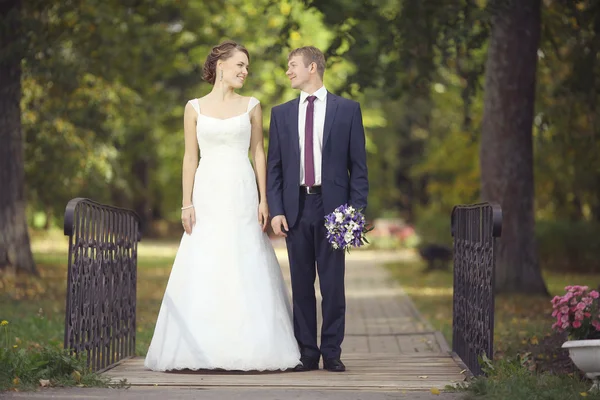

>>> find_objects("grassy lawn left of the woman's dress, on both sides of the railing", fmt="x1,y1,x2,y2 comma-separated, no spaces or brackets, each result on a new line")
0,234,179,355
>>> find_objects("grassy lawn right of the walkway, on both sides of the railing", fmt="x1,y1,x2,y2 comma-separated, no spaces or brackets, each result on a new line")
389,262,600,400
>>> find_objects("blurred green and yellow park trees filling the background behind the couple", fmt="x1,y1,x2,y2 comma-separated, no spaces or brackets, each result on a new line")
0,0,600,292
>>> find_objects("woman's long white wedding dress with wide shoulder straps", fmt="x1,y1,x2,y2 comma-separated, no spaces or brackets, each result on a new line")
144,97,300,371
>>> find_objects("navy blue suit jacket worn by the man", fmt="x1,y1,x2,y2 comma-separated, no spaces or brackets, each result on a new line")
267,92,369,229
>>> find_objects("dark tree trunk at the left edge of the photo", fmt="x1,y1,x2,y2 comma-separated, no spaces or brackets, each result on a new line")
0,0,37,275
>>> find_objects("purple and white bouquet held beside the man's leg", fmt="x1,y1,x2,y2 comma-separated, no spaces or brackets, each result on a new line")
325,204,373,252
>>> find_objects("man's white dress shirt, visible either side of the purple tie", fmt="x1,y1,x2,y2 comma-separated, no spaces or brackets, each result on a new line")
298,86,327,186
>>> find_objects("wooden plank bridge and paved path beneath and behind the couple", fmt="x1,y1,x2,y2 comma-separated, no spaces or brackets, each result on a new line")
105,249,465,392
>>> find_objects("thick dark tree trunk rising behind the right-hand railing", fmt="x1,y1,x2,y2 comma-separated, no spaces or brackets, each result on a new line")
480,0,548,295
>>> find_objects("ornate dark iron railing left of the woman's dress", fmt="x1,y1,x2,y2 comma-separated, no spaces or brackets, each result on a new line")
64,198,141,372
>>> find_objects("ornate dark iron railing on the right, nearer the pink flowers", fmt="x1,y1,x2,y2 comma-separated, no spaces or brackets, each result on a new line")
451,203,502,375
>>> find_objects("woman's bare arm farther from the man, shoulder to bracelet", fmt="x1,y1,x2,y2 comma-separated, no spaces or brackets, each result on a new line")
181,102,198,207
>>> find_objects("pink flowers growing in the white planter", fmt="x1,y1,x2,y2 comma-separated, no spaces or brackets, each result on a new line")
552,286,600,340
